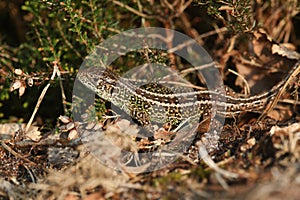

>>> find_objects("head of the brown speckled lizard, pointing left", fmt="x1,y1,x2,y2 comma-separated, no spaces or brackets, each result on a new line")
77,67,119,100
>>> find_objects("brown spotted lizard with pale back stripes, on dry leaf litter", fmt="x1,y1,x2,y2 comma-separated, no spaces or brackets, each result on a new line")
77,61,300,125
